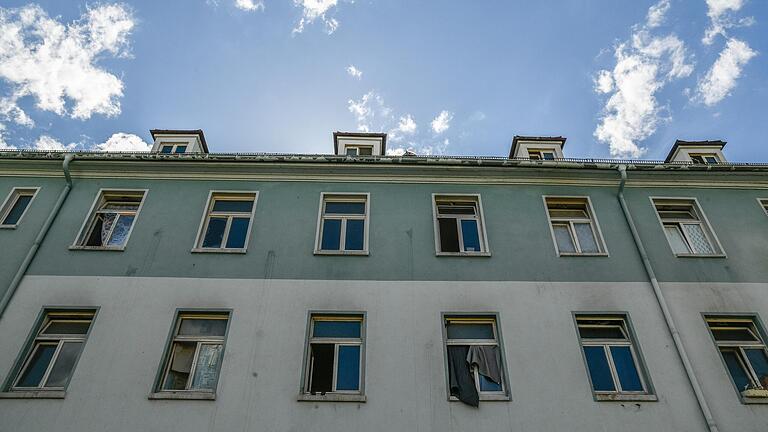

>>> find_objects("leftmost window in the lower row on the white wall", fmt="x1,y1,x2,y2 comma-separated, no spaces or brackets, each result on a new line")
11,309,96,391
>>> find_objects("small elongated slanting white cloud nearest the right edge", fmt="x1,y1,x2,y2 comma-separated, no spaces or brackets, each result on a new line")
695,39,757,106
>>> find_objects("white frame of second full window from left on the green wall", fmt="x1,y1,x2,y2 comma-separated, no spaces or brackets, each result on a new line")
192,190,259,253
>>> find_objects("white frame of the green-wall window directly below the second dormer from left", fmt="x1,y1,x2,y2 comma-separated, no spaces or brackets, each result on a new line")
314,192,371,255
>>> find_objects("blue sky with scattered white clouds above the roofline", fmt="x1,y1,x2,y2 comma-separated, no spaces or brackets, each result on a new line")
0,0,768,161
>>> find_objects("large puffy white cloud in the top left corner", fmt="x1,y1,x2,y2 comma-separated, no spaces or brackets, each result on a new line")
0,4,135,126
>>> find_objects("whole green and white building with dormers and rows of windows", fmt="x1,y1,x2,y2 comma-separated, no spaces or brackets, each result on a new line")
0,130,768,431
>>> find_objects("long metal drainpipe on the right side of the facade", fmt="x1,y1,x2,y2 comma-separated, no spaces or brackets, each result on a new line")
616,165,719,432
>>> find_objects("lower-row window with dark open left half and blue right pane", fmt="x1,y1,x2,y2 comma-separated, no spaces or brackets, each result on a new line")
300,313,365,401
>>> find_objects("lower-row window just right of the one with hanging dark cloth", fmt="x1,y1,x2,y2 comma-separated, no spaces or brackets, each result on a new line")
576,315,651,400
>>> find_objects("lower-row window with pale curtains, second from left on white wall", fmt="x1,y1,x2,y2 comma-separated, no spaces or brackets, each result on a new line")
156,311,230,393
